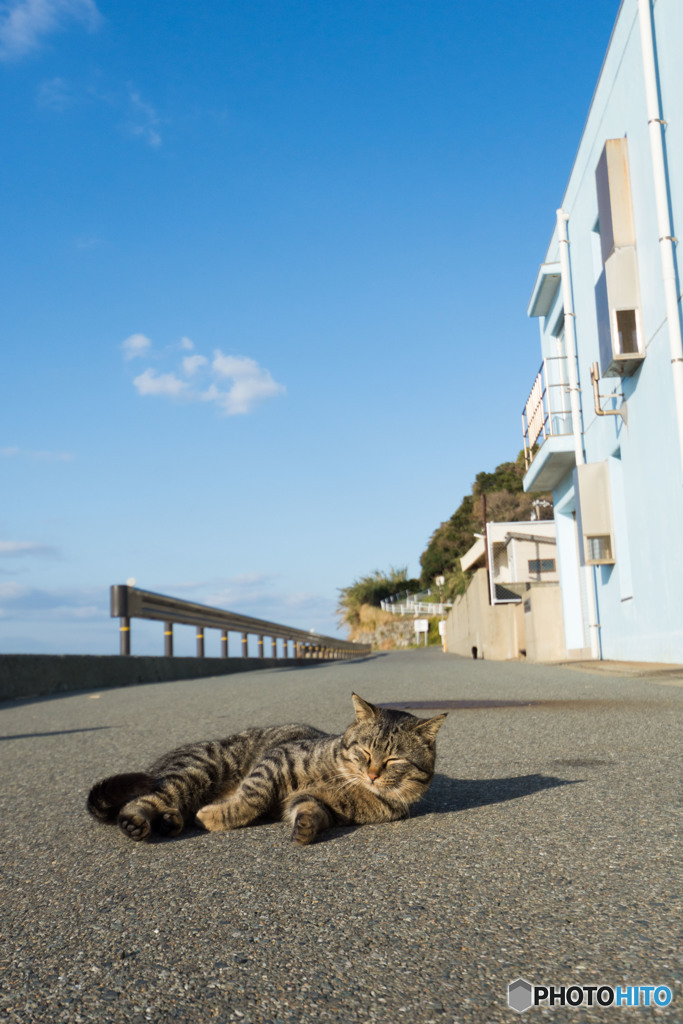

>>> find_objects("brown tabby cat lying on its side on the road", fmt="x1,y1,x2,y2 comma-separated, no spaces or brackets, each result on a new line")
87,693,445,845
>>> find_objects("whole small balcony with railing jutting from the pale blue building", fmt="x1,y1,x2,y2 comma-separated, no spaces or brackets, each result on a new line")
522,355,575,493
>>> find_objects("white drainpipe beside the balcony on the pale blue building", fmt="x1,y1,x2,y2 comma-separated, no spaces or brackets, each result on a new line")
557,210,601,660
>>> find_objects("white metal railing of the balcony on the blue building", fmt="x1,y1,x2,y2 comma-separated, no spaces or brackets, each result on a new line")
522,355,571,469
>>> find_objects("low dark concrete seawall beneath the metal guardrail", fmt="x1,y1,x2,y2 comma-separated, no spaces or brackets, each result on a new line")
0,654,317,700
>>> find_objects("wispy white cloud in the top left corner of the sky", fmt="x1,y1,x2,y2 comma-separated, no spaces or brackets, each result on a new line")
0,0,101,60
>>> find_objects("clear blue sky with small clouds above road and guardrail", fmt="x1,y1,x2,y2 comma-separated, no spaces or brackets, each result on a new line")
0,0,618,653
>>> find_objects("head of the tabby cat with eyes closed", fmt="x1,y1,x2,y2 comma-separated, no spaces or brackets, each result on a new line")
344,693,446,804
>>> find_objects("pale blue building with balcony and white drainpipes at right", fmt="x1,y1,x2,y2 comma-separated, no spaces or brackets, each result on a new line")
522,0,683,663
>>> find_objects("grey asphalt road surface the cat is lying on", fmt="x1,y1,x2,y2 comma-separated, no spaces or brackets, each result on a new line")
0,648,683,1024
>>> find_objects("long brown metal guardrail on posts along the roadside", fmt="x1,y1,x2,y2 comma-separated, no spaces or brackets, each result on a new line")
111,584,372,659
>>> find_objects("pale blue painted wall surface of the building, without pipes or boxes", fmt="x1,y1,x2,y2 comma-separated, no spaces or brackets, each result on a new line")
529,0,683,663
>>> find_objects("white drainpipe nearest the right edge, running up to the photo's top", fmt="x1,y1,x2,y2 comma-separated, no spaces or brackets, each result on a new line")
638,0,683,479
